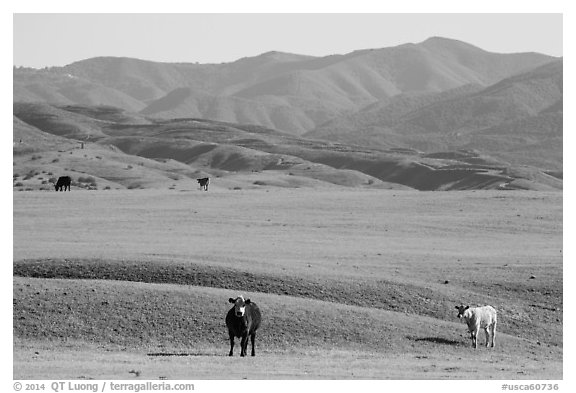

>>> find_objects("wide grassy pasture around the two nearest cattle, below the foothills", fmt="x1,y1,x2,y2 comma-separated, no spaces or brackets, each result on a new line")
13,187,563,379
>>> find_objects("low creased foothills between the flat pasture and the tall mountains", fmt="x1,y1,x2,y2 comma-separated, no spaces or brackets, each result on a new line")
14,103,562,190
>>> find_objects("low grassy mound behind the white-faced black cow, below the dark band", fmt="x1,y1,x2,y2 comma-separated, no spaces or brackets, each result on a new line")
14,278,539,354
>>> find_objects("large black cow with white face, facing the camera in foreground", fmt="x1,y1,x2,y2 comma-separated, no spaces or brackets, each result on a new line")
226,296,262,356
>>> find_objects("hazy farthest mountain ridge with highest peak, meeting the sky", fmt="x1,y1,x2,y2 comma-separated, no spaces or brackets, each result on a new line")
14,37,555,134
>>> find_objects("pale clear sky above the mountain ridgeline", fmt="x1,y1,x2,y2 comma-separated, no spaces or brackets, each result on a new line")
13,13,563,68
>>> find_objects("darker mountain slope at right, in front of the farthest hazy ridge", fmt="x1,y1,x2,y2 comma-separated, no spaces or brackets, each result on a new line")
305,61,563,170
